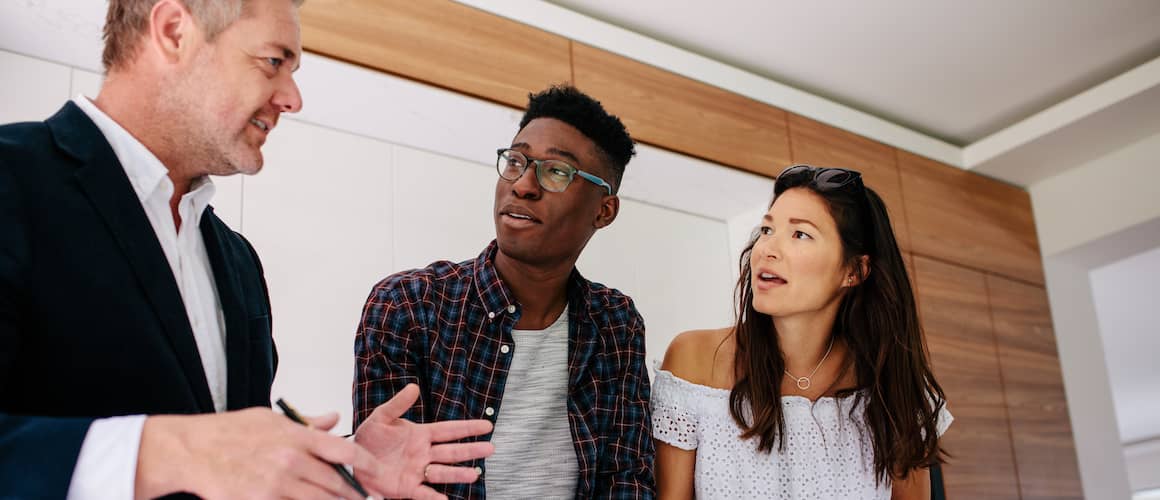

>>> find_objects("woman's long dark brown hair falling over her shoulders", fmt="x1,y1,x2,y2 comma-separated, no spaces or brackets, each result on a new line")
730,166,947,481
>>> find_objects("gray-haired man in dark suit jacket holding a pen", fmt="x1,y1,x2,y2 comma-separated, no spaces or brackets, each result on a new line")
0,0,491,499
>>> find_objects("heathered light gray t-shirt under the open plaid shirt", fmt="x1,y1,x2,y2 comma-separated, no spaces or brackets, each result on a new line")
485,307,580,500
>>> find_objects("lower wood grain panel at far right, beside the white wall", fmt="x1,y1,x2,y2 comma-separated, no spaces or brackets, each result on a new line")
987,276,1083,500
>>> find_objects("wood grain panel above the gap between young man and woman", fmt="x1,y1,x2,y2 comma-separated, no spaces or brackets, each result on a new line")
572,43,791,176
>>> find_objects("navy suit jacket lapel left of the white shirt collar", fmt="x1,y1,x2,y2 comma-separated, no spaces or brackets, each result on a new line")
46,102,213,412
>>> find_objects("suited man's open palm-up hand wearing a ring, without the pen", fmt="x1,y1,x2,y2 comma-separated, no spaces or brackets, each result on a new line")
355,384,495,500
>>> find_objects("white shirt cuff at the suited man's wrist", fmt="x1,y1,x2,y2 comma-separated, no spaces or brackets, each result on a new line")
67,415,145,500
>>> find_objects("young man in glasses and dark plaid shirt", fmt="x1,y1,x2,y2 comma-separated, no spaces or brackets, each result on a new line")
354,86,654,498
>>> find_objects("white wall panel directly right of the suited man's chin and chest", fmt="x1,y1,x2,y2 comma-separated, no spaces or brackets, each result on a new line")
241,119,394,429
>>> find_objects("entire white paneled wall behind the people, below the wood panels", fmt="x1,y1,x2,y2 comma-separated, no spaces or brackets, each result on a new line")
0,46,771,430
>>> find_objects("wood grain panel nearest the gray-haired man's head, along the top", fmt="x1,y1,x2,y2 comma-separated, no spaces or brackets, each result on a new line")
300,0,572,109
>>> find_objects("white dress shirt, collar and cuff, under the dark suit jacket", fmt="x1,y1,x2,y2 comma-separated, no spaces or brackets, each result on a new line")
68,95,226,500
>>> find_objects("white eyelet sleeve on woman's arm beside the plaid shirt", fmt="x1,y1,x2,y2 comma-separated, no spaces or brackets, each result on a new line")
651,368,697,450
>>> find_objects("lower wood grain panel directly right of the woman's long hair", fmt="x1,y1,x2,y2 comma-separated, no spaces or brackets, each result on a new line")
914,255,1018,499
